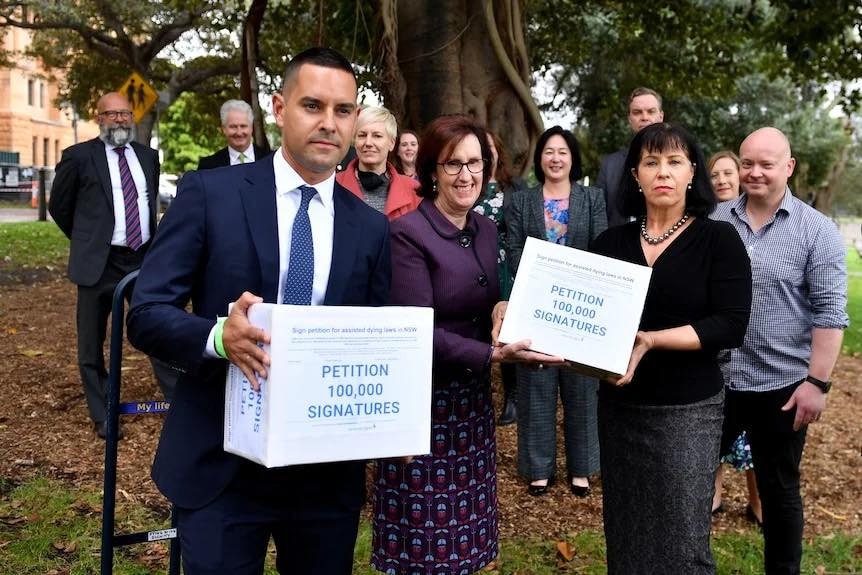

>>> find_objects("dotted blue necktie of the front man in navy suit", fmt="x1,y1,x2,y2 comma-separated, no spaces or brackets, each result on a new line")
282,186,317,305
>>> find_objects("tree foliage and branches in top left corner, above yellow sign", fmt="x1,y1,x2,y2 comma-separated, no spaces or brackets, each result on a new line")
0,0,245,118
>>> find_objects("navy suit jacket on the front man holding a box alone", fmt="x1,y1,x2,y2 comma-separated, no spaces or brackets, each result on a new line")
127,161,390,509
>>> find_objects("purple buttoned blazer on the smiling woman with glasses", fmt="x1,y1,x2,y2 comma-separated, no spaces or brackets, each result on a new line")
389,199,500,379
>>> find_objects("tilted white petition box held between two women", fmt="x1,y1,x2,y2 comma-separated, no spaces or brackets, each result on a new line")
500,238,652,377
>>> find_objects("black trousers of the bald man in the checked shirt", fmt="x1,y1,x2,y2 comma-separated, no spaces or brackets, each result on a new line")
721,383,808,575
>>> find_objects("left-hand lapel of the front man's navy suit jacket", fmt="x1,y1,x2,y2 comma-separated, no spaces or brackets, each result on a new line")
240,162,279,303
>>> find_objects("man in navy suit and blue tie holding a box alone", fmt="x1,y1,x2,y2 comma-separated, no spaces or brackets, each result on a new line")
127,48,390,575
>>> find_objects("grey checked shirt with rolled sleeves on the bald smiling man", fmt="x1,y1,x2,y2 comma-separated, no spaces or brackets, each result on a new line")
710,188,849,391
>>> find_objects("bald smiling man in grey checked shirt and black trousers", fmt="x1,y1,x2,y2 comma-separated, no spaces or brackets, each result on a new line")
711,128,849,575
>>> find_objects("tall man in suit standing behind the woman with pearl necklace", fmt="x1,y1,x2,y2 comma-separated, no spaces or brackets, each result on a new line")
596,88,664,227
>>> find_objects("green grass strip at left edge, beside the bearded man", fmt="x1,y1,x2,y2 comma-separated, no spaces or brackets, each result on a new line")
0,222,69,268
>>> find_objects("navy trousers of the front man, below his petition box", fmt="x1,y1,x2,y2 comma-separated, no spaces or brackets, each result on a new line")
176,487,359,575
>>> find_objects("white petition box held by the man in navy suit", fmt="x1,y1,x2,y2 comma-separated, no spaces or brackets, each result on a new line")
224,304,434,467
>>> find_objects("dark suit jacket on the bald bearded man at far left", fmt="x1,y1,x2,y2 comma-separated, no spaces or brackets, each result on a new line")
48,138,159,286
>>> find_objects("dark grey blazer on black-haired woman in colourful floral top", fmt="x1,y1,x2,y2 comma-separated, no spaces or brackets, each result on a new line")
506,184,608,275
